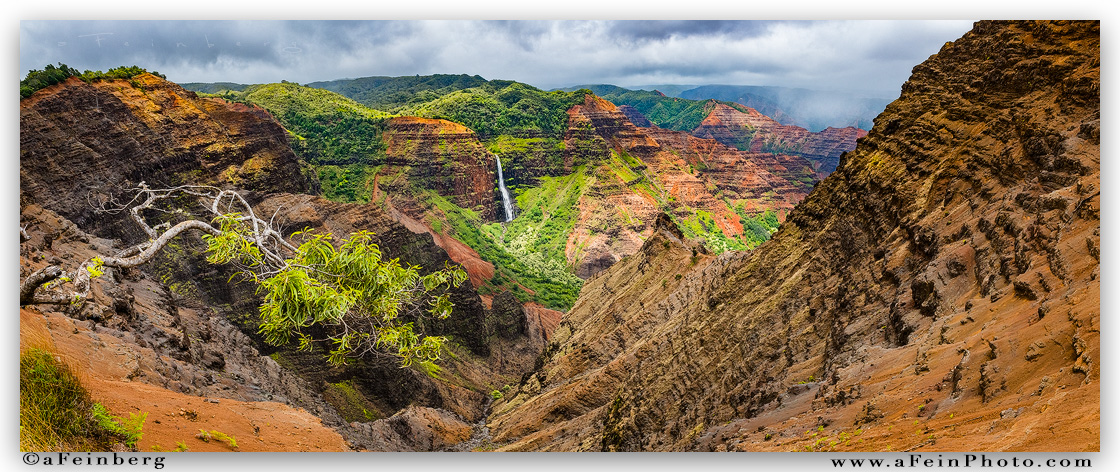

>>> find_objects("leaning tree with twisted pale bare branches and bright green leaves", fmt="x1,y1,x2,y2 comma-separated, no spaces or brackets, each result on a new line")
20,183,467,367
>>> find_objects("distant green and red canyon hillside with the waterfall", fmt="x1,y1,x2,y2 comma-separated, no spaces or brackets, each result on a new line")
221,76,855,311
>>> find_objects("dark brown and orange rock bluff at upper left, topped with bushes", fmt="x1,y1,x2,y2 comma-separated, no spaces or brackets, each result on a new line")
19,73,309,235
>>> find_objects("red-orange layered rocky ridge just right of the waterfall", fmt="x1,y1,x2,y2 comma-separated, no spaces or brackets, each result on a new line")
564,95,814,278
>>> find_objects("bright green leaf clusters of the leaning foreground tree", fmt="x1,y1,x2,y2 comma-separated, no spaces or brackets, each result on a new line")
203,217,467,367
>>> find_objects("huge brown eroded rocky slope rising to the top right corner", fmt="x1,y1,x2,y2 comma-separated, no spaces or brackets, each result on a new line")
488,21,1101,451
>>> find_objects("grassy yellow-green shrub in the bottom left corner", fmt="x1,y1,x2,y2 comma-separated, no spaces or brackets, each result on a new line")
19,349,148,451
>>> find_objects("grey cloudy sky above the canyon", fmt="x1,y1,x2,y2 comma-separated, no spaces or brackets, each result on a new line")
19,20,972,98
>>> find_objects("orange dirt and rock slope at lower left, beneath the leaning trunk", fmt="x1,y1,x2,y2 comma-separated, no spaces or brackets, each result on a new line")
20,204,348,451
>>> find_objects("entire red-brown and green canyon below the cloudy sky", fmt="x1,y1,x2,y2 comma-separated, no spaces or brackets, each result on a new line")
20,21,1102,451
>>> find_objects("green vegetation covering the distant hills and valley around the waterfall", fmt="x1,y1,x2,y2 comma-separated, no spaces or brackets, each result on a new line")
190,75,776,309
